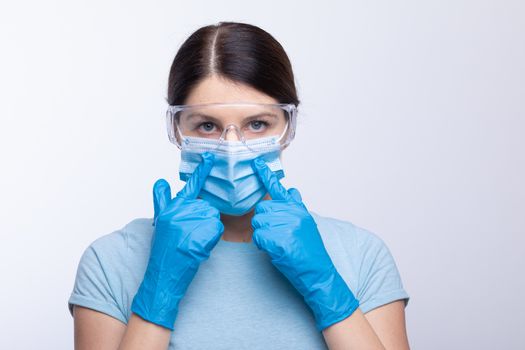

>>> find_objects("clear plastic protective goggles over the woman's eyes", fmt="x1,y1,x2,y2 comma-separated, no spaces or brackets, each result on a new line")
166,103,297,149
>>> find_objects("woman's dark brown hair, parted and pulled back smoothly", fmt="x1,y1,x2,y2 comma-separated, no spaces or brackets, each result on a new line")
167,22,299,106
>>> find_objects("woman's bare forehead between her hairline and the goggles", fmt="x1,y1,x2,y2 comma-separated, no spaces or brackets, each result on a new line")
184,74,278,105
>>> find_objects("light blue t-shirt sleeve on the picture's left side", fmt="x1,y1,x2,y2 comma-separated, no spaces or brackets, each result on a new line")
68,234,127,323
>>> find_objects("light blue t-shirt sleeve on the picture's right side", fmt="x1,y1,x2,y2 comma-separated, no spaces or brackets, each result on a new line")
356,228,410,313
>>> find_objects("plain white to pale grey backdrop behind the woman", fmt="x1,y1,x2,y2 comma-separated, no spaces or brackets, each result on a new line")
0,0,525,350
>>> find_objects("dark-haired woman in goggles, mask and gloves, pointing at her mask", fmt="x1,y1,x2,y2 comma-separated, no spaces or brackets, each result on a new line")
69,22,409,349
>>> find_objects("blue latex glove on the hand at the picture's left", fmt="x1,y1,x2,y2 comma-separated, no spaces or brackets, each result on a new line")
131,153,224,330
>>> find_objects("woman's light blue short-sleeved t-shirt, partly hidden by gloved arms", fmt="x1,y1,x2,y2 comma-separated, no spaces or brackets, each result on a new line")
69,213,409,349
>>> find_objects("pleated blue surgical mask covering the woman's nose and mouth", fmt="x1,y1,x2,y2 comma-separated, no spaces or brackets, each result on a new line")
179,137,284,216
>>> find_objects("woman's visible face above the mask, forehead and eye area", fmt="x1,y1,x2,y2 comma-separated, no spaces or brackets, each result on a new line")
181,75,286,140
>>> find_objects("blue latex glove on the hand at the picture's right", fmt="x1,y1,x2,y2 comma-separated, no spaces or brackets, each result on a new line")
252,158,359,331
